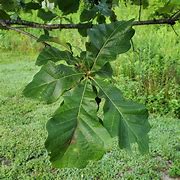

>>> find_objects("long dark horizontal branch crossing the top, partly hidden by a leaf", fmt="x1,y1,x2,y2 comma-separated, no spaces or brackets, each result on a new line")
0,15,180,30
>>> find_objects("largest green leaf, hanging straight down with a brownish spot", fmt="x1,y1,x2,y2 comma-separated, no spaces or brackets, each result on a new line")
45,80,112,168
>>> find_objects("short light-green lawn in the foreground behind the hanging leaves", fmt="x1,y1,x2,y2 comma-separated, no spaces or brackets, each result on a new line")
0,53,180,180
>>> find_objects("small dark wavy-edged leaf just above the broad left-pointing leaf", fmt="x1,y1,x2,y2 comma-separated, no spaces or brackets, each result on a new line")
36,47,73,66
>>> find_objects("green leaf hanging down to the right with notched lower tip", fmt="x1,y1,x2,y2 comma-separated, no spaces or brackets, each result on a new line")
93,79,150,153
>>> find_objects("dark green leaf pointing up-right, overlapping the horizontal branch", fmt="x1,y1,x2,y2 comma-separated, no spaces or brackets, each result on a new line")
86,20,135,70
